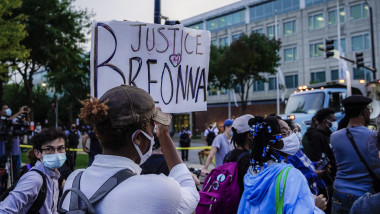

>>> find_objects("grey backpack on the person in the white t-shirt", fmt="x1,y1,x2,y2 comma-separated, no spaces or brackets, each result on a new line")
58,169,134,214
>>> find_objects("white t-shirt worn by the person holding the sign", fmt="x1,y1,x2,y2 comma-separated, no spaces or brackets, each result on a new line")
62,155,199,214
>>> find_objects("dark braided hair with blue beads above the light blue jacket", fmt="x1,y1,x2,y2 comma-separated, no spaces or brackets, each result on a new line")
251,116,283,166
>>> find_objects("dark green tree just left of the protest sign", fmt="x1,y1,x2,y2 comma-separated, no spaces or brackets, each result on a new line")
13,0,90,117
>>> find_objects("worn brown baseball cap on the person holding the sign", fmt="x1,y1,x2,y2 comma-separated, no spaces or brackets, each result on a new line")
99,85,171,127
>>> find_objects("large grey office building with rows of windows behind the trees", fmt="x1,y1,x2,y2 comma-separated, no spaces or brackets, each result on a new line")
181,0,380,134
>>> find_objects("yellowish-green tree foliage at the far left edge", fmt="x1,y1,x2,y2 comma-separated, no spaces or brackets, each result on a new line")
0,0,29,103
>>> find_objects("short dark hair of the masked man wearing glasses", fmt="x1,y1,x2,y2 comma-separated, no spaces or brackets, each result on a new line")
31,128,67,151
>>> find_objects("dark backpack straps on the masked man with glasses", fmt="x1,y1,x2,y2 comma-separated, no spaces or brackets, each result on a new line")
0,169,47,214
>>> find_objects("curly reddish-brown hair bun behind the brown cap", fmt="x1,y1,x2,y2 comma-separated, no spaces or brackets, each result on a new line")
78,95,109,125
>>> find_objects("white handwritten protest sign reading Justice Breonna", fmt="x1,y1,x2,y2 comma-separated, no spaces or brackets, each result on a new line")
91,21,211,113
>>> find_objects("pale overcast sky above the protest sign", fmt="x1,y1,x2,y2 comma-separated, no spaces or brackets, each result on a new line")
74,0,239,51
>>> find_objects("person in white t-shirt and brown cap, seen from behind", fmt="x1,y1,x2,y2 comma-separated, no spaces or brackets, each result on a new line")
62,85,199,214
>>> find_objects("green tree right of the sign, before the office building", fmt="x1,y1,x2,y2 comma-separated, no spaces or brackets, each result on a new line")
209,33,281,114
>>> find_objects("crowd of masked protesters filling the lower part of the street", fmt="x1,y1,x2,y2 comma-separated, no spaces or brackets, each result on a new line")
0,85,380,214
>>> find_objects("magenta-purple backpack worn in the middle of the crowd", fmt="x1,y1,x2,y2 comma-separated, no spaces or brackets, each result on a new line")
196,153,247,214
